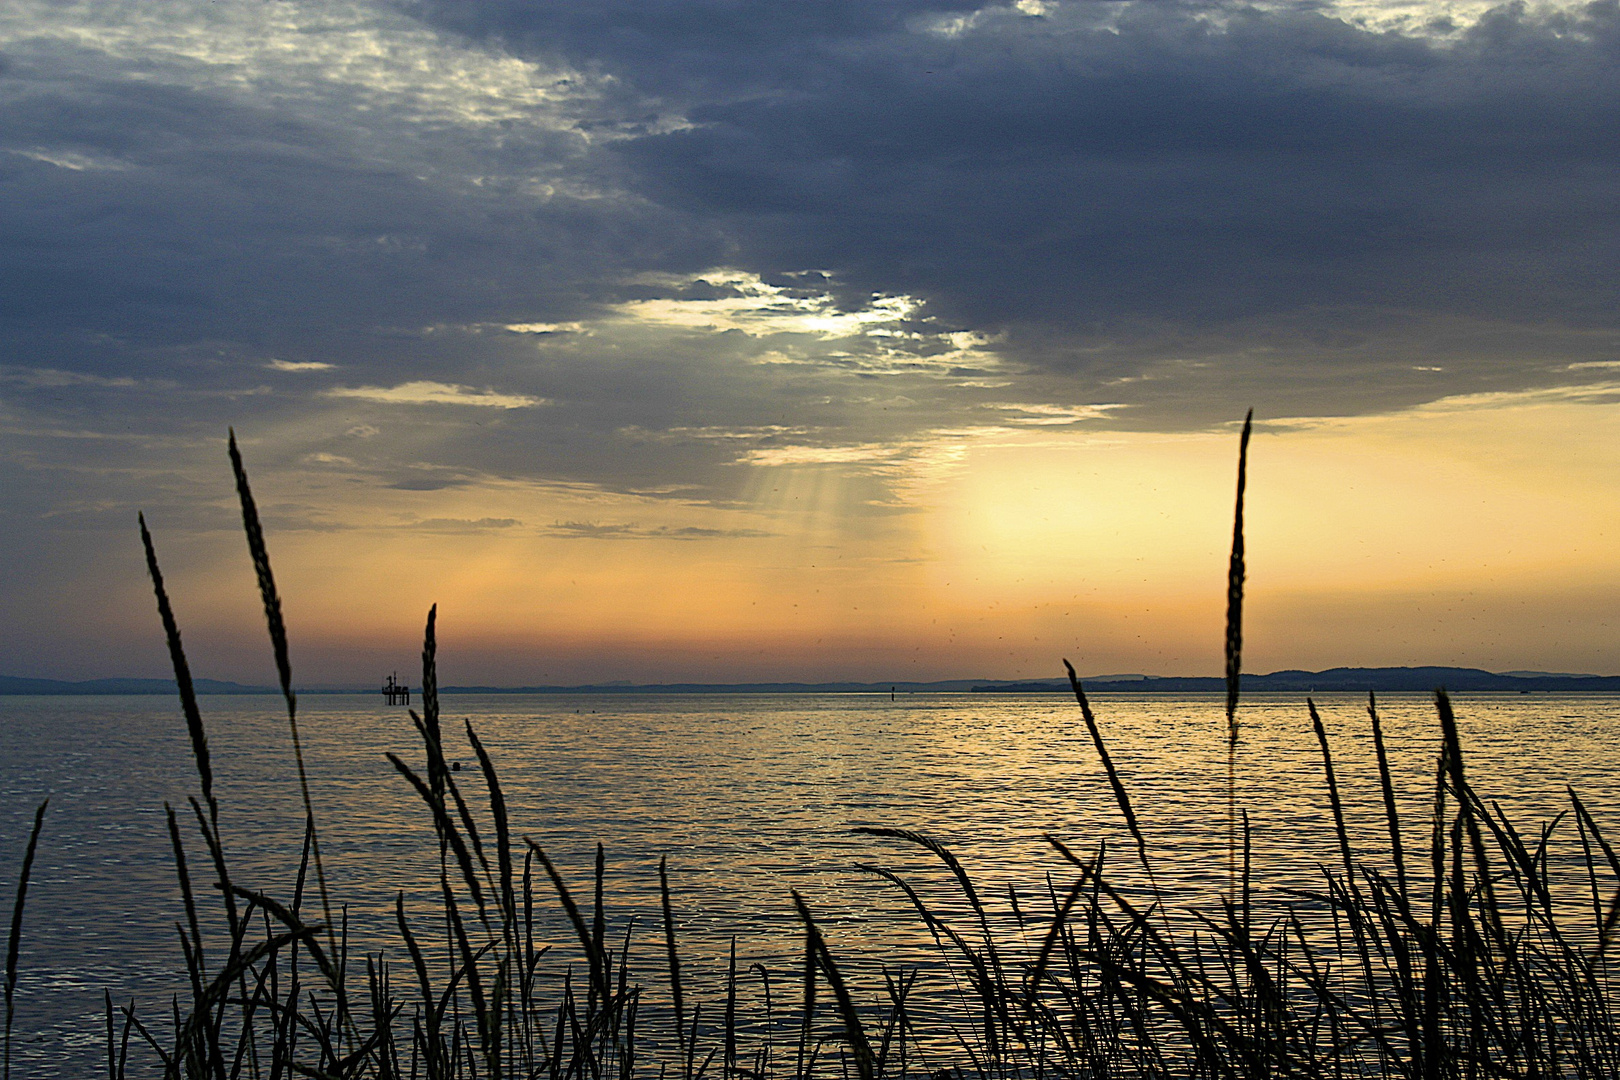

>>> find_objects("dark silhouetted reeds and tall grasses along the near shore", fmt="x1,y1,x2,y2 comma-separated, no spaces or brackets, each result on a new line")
5,427,1620,1080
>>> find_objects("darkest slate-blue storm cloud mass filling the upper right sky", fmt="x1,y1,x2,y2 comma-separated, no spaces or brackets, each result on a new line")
416,0,1620,424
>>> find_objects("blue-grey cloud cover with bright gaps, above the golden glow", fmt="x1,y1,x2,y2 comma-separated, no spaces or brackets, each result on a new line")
0,0,1620,680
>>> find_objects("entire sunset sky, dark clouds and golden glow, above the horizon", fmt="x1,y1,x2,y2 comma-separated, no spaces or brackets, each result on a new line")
0,0,1620,685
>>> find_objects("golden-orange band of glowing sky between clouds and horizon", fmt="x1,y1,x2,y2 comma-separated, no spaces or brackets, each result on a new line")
101,389,1620,683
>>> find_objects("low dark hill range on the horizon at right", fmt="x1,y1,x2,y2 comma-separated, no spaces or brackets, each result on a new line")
974,667,1620,693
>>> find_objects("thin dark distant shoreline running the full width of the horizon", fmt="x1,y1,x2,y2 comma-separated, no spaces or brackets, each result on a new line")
0,667,1620,696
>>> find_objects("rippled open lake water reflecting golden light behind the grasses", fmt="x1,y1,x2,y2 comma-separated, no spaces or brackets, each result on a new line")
0,695,1620,1077
